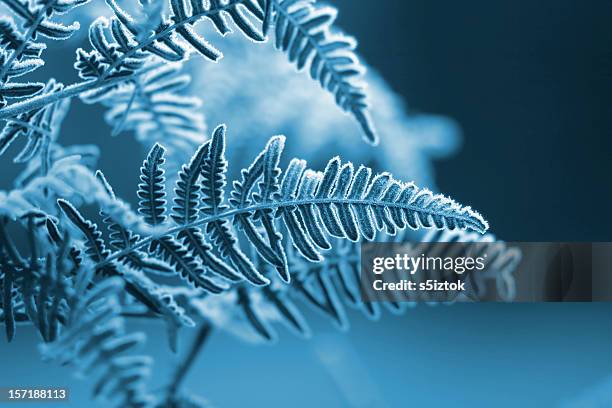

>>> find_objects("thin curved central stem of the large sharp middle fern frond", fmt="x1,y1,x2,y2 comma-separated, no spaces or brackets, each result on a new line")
96,197,486,268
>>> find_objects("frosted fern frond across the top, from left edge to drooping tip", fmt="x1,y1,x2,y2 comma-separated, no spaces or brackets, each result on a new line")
0,0,377,148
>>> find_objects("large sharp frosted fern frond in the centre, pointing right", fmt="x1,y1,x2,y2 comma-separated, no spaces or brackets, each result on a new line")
61,125,488,293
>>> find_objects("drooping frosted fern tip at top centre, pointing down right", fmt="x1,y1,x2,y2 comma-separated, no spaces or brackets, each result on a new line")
260,0,378,144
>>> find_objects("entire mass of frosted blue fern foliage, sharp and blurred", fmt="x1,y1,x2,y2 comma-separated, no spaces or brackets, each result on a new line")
0,0,521,407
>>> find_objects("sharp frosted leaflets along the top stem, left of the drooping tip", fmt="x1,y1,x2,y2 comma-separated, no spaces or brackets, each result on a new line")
75,0,263,83
